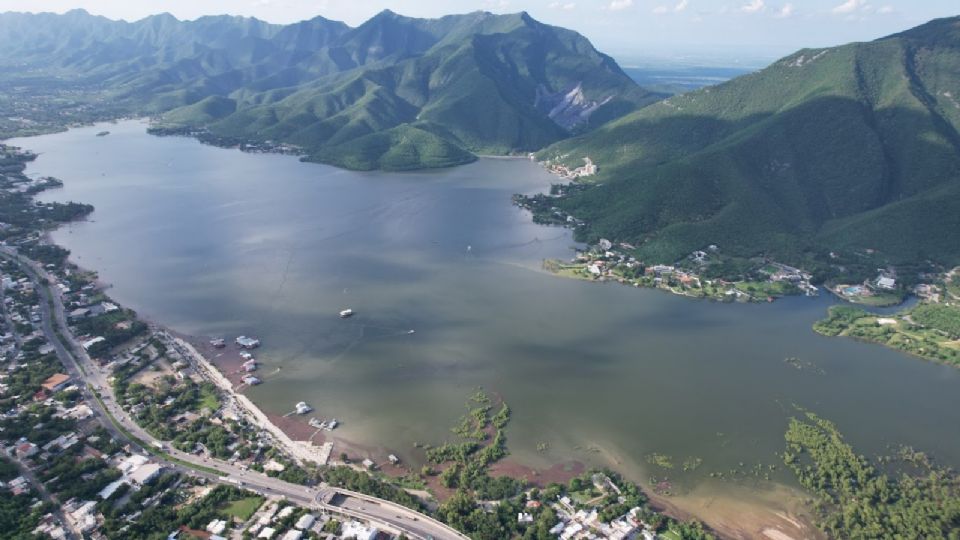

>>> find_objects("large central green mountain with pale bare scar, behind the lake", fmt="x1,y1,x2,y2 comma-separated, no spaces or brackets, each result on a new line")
164,11,657,169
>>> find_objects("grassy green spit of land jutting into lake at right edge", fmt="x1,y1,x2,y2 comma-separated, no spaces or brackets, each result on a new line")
813,304,960,367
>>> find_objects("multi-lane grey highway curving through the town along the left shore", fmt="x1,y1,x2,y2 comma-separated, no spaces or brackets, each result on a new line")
0,251,469,540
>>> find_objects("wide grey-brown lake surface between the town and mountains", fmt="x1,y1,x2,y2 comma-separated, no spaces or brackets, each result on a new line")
12,122,960,516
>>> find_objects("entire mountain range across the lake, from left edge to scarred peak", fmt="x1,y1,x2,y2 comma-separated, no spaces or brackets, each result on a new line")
0,10,661,169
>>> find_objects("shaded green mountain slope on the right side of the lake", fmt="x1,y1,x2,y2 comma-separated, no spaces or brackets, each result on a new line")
539,18,960,264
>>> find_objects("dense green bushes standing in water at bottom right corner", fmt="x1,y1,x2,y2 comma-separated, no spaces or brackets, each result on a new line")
783,412,960,538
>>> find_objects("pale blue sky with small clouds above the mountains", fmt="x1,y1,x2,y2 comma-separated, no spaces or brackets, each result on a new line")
0,0,960,65
